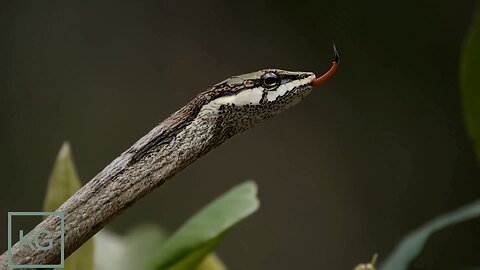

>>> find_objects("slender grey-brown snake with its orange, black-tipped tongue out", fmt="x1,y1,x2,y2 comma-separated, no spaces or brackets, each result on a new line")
0,46,339,269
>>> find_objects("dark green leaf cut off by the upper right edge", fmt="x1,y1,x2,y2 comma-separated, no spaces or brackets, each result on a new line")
460,3,480,161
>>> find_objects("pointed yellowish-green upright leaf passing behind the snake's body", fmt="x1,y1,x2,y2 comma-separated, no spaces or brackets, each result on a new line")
43,142,93,270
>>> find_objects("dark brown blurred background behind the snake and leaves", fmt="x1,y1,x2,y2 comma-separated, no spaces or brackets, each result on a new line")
0,0,480,269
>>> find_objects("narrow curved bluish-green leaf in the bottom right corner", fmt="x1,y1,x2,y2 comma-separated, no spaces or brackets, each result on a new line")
379,200,480,270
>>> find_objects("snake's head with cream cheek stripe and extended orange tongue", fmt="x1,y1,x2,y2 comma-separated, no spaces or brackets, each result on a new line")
204,48,339,133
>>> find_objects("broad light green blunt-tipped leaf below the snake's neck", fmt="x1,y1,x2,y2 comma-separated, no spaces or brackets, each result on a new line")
150,181,259,270
